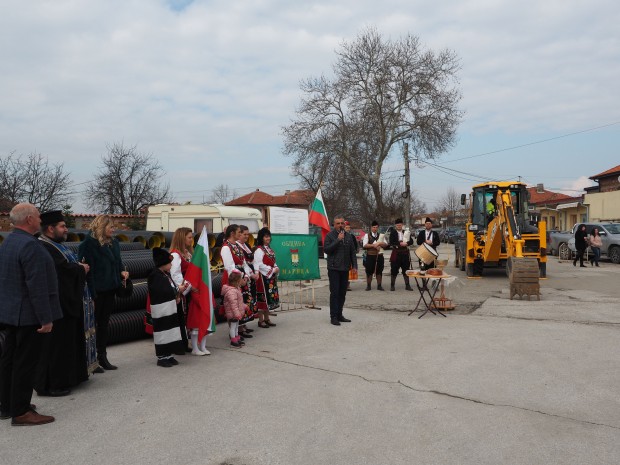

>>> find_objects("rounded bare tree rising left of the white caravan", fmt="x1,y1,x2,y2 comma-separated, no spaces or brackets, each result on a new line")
86,142,171,215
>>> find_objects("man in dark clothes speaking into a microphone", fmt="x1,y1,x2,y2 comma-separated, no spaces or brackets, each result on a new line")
323,215,357,326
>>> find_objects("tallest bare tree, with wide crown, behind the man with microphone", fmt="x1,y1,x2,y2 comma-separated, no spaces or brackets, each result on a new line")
282,28,462,217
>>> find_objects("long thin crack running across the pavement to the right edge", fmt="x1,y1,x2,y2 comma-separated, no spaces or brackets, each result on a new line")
221,348,620,430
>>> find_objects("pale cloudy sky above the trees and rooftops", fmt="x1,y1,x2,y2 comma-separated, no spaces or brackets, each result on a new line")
0,0,620,213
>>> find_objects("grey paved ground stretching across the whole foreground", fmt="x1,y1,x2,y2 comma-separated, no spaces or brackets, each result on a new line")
0,246,620,465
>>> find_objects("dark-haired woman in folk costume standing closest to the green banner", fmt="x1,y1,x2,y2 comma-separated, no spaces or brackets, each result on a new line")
254,228,280,328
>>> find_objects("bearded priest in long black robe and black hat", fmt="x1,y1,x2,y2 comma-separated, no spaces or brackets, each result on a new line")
35,210,89,397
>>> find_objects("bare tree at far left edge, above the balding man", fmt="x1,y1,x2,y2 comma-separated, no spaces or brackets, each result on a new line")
0,152,70,211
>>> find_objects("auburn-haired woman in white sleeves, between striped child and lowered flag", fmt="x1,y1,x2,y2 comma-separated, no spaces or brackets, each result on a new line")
170,228,194,352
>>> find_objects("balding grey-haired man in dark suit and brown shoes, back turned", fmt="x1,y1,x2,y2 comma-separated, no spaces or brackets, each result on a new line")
0,203,62,426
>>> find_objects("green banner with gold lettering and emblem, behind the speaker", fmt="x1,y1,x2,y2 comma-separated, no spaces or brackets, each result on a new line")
270,234,321,281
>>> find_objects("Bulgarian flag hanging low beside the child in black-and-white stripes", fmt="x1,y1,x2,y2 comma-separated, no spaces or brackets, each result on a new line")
185,226,216,341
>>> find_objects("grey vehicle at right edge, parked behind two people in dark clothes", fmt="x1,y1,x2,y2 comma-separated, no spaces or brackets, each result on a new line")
547,223,620,263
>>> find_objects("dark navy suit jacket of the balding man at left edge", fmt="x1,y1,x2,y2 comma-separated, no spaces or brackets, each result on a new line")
0,228,62,326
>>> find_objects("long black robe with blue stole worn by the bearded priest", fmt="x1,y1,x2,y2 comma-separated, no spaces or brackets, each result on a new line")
35,232,92,394
